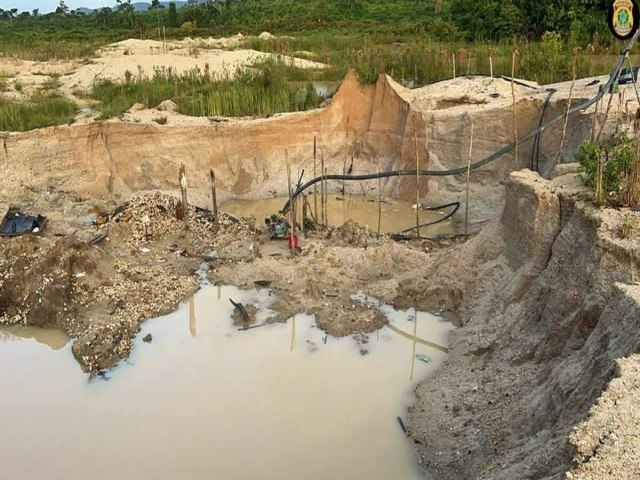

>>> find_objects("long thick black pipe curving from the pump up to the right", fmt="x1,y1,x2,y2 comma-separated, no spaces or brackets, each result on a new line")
282,30,640,214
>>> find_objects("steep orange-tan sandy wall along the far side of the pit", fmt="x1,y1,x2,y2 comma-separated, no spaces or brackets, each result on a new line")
0,73,604,216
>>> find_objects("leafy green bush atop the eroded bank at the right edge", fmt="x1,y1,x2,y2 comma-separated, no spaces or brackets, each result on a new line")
576,132,640,206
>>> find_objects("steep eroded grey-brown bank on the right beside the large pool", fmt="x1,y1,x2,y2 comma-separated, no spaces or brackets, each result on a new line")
408,171,640,480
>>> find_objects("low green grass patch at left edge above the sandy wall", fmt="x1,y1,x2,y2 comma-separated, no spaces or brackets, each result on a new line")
0,93,76,132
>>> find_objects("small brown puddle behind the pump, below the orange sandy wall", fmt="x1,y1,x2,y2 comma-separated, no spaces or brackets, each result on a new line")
221,194,455,236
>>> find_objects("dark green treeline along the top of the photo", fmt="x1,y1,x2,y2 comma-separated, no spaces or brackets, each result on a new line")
0,0,611,45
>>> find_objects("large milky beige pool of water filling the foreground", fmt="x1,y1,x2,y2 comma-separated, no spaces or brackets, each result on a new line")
0,285,452,480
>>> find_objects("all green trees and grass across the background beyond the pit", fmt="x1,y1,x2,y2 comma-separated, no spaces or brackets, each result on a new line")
0,0,640,129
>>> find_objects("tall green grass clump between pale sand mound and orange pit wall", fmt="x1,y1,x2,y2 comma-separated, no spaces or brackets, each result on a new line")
92,60,324,118
